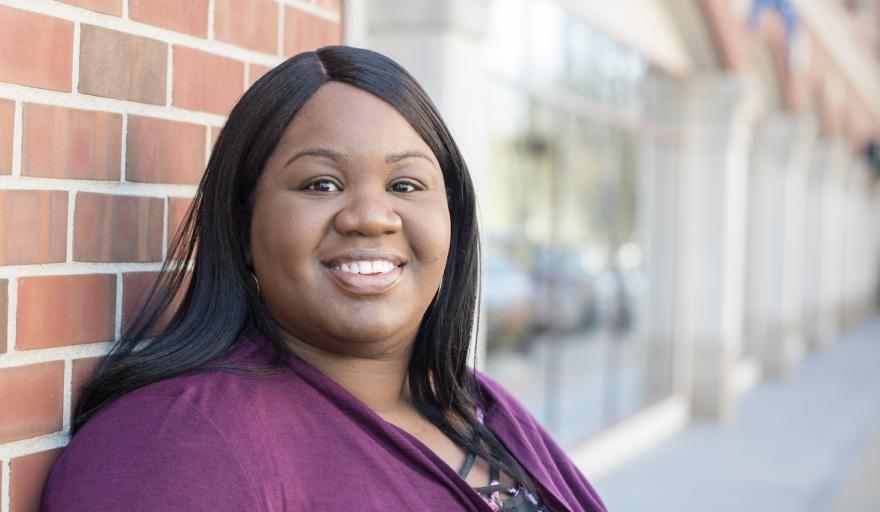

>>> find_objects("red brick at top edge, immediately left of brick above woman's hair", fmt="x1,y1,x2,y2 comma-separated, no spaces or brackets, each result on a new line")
214,0,278,53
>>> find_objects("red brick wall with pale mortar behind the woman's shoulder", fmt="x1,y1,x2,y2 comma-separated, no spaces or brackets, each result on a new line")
0,0,341,512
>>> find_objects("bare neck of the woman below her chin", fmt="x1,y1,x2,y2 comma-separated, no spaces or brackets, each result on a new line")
285,335,412,417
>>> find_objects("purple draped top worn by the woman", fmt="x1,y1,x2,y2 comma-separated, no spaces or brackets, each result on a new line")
43,336,605,512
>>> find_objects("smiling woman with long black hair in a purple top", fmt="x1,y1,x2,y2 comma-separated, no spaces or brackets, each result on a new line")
43,46,604,512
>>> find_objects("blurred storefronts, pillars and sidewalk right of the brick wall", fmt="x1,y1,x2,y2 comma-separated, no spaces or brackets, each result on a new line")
343,0,880,511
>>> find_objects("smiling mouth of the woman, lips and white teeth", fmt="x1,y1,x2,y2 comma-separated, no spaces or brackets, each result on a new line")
322,254,406,295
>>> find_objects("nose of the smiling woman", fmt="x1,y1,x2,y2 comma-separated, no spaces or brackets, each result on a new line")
333,190,402,236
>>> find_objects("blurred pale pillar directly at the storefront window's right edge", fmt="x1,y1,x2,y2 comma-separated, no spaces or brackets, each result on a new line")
677,75,753,419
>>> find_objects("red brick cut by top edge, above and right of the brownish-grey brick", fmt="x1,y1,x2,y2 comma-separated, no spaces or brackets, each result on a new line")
128,0,208,37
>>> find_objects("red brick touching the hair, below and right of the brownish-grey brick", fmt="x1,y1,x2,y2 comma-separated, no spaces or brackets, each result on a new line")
125,115,206,184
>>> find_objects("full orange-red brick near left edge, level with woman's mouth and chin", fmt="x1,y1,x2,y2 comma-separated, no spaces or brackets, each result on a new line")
15,274,116,350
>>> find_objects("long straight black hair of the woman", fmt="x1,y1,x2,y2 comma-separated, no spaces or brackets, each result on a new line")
73,46,531,486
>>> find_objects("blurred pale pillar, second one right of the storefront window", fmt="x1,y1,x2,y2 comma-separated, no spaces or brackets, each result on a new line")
746,114,814,376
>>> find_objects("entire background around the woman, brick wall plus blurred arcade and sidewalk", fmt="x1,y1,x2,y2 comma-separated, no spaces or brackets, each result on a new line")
0,0,880,512
